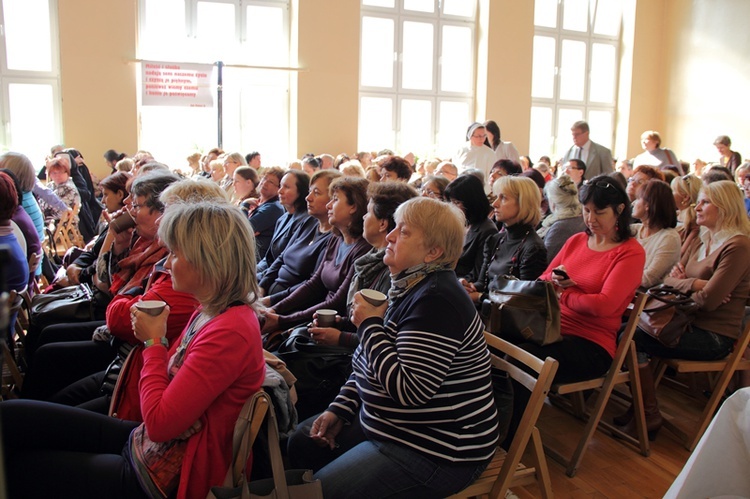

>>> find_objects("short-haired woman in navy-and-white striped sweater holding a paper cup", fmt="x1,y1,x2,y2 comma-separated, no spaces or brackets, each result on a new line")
289,197,498,499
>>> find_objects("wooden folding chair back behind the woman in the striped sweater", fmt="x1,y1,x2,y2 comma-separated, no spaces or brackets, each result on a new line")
484,332,557,497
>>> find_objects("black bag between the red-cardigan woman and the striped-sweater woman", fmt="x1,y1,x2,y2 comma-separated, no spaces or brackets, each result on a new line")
275,326,353,421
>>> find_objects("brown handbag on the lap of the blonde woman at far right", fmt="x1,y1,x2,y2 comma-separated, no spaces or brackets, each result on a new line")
638,284,698,348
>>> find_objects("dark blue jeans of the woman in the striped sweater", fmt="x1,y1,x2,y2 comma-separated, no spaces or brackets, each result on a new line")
289,418,489,499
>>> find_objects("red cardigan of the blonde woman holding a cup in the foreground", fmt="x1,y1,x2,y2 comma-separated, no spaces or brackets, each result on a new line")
140,305,265,499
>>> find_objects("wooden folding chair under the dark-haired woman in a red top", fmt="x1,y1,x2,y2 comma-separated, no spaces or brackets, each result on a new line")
544,293,651,477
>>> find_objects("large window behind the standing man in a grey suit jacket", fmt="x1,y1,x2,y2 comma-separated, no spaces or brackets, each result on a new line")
529,0,622,158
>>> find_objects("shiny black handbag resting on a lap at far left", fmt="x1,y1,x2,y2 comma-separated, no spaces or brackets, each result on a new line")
31,284,95,323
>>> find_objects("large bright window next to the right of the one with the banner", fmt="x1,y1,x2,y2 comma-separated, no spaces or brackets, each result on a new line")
358,0,476,156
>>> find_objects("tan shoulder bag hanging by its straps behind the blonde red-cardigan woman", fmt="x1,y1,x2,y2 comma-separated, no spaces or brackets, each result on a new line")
207,390,323,499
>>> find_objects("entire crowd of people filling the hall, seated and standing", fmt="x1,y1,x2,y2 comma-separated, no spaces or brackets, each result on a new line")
0,121,750,498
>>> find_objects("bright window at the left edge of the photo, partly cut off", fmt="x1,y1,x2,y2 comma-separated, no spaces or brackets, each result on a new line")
0,0,62,167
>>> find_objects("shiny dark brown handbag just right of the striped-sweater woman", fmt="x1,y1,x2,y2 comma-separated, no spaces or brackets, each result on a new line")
482,276,562,346
